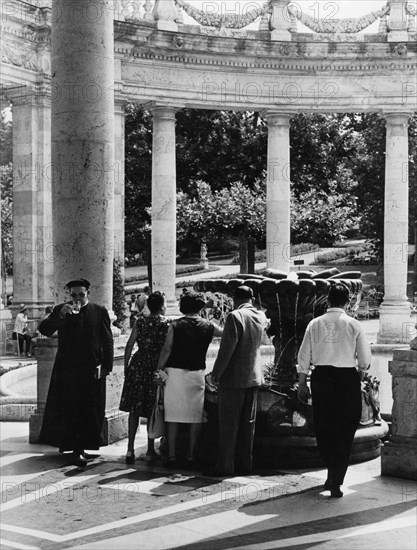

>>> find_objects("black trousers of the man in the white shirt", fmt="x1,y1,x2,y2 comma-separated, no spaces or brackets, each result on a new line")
311,365,362,485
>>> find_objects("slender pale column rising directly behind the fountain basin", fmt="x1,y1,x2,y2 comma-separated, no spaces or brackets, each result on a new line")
266,112,291,272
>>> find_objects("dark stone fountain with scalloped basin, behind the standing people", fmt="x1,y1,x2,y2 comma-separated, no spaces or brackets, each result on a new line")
194,268,388,467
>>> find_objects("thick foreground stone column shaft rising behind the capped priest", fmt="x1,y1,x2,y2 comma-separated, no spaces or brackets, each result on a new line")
51,0,115,309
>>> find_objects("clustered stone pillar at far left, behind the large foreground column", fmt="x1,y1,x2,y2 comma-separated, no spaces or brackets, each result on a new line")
11,85,53,318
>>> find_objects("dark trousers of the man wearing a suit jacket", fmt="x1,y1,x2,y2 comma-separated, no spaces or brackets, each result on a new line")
216,386,258,475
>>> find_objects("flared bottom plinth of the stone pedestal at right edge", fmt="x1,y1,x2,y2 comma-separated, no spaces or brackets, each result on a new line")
381,436,417,481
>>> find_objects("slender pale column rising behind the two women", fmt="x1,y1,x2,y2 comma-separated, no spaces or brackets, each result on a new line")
151,105,177,312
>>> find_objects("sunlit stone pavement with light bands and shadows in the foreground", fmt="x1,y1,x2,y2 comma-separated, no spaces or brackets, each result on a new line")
0,423,417,550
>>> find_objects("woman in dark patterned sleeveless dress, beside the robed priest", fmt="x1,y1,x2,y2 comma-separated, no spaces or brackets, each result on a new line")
119,292,170,464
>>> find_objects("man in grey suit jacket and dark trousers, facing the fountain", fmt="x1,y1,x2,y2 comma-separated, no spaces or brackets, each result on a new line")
208,286,269,475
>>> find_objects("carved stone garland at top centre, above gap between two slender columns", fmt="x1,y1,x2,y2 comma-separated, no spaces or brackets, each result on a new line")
175,0,271,29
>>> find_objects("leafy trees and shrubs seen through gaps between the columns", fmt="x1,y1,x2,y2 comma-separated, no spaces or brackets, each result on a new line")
126,106,417,255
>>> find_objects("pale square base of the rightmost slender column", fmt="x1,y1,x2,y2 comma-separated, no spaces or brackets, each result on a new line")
377,302,415,344
